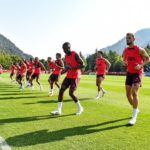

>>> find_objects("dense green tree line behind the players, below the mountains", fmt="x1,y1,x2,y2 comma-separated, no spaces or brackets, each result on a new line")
0,45,150,72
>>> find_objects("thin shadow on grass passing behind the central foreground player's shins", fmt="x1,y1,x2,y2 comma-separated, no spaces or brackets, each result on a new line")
23,98,92,105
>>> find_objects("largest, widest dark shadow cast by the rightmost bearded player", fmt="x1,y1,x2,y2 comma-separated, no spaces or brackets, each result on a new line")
6,118,129,147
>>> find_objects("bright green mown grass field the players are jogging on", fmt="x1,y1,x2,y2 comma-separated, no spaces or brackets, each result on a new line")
0,74,150,150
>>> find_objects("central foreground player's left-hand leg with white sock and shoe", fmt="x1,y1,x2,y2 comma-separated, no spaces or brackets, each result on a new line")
51,78,71,115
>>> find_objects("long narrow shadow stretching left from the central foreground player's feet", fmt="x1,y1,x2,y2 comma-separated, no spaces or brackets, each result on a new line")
0,113,75,124
